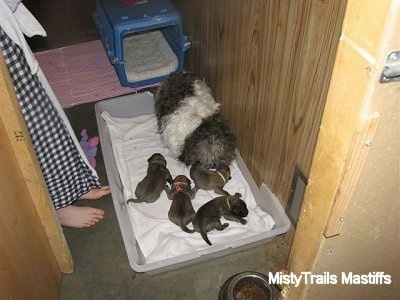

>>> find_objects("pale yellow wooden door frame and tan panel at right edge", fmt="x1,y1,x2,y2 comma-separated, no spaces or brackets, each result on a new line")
284,0,400,299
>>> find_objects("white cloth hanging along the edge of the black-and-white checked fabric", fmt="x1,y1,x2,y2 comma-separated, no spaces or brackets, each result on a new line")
0,0,98,177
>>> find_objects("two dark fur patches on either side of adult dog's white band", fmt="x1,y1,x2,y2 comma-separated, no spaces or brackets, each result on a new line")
155,73,236,168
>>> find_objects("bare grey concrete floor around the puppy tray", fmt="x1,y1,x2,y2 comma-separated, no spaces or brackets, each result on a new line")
60,103,288,300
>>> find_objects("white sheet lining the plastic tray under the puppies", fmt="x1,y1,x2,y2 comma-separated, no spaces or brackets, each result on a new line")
102,112,275,263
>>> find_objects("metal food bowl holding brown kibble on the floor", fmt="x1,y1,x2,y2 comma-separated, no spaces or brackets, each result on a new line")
218,271,279,300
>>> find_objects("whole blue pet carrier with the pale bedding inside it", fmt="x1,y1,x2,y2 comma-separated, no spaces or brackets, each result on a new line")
92,0,190,88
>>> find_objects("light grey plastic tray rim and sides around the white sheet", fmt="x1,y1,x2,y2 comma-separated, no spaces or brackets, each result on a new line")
95,92,290,274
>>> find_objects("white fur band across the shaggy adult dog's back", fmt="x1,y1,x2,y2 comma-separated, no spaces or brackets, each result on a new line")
161,80,220,158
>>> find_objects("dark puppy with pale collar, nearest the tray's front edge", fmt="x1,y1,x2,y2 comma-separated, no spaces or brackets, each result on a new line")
192,193,249,246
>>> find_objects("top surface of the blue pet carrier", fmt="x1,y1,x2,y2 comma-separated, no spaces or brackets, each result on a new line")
98,0,180,26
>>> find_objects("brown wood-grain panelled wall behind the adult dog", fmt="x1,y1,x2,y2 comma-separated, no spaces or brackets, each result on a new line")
173,0,347,206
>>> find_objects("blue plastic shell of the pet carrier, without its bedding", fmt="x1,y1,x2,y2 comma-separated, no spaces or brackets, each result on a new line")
93,0,190,87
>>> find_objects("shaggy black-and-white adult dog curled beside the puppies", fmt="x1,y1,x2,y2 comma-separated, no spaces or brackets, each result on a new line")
155,73,236,168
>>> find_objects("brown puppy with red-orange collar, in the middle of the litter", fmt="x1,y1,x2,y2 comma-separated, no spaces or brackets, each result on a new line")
165,175,196,233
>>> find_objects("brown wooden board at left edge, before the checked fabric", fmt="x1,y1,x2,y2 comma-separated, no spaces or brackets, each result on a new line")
0,51,64,299
